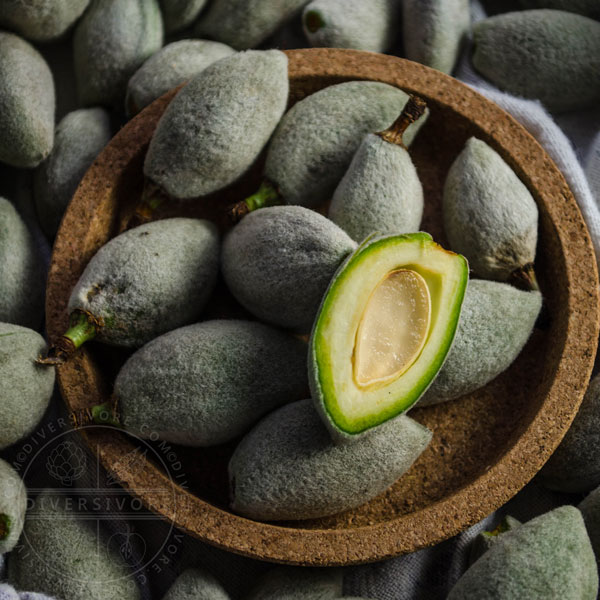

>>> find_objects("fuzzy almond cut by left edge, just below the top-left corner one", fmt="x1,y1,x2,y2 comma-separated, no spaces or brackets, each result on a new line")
0,31,56,168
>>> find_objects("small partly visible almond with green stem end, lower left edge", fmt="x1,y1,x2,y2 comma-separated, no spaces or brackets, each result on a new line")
0,458,27,554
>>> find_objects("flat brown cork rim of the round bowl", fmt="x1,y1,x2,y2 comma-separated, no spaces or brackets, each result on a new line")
46,49,600,566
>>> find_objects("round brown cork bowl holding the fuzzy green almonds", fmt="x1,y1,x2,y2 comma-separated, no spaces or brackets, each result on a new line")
47,49,599,566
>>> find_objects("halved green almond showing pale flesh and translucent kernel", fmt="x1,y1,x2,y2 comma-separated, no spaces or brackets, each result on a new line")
309,233,469,441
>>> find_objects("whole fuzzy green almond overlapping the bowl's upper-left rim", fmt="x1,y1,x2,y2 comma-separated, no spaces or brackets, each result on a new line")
144,50,289,199
